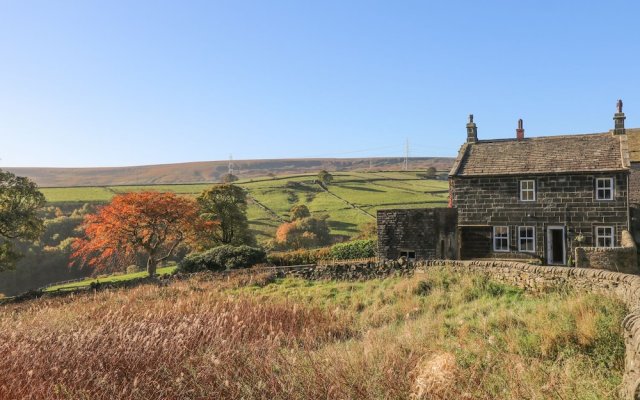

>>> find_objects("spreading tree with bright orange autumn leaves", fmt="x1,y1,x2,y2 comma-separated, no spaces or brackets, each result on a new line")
72,192,211,276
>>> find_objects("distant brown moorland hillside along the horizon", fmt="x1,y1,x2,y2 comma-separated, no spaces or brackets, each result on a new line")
4,157,453,187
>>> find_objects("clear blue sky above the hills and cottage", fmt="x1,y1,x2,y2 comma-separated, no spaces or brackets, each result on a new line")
0,0,640,167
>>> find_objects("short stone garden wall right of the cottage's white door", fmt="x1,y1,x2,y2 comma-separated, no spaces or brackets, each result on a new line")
575,231,639,274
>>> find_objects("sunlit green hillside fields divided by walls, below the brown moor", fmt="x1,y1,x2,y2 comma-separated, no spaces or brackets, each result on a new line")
41,171,448,240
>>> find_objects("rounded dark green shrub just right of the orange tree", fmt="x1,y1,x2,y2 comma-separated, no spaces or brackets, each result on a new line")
178,245,266,273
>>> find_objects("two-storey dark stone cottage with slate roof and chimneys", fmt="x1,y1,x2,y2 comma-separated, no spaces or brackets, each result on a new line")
378,101,640,265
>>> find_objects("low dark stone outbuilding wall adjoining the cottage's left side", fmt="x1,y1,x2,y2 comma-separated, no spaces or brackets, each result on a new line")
377,208,457,260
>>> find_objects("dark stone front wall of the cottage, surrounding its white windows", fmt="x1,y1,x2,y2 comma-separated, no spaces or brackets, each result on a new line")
449,172,629,260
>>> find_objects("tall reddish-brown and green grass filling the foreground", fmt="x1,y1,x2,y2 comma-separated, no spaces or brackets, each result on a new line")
0,271,625,399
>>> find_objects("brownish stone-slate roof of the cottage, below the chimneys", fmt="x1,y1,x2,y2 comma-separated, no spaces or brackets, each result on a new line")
449,129,640,176
